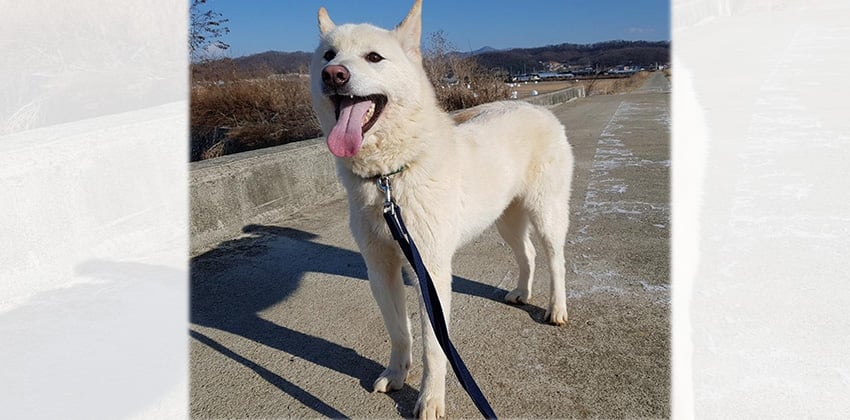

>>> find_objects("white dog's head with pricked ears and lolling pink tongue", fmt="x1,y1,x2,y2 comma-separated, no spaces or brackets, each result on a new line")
310,0,430,157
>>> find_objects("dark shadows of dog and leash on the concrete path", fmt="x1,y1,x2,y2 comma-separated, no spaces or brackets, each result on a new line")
190,225,543,418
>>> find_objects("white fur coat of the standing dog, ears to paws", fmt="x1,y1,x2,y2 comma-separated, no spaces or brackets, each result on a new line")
310,0,573,418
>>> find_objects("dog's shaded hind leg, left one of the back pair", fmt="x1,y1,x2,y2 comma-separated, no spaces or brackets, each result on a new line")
496,200,537,303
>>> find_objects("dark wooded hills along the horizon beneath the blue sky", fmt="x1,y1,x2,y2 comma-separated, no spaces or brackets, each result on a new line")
210,41,670,73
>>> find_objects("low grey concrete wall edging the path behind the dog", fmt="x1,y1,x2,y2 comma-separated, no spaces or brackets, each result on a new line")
189,87,584,255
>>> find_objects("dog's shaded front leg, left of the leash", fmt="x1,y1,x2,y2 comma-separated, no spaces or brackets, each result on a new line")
361,242,412,392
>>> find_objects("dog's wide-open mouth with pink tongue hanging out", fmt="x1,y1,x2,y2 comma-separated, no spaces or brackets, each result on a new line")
327,95,387,157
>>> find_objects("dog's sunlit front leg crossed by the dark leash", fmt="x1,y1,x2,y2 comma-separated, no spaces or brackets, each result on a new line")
414,256,452,419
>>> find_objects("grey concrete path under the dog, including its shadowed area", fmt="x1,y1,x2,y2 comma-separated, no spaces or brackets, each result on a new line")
189,73,670,418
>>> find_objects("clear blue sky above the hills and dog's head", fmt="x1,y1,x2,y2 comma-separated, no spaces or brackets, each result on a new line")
206,0,670,57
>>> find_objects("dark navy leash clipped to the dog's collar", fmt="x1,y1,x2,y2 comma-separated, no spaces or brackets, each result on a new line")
378,171,496,419
